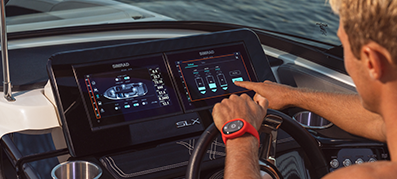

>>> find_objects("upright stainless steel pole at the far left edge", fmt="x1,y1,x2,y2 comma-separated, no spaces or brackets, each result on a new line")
0,0,15,102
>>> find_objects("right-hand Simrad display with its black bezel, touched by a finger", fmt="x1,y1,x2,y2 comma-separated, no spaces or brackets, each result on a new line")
167,43,257,110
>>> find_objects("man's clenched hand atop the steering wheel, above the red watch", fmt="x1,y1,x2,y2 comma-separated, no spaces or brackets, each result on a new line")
212,94,268,131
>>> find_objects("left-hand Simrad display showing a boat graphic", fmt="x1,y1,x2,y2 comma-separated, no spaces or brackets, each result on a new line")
75,55,181,128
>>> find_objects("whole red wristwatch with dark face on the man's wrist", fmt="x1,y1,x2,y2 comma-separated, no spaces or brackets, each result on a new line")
222,118,260,145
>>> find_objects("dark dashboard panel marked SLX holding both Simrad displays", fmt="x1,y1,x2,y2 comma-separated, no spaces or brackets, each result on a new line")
47,29,275,157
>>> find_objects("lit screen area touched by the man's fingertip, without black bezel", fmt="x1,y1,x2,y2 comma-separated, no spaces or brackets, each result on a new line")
176,52,251,102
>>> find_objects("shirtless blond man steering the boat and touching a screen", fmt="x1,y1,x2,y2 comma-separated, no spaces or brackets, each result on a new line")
213,0,397,179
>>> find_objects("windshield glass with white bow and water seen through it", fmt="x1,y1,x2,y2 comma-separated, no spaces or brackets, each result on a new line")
6,0,340,46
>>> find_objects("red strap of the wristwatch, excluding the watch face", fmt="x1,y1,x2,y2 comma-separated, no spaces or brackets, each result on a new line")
221,118,260,145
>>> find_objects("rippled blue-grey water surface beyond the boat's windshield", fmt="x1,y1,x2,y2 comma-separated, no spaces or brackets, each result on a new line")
122,0,340,45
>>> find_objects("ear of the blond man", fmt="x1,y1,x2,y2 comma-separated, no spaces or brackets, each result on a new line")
361,42,392,80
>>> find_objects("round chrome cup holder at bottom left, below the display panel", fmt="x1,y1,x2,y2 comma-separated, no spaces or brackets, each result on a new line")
51,161,102,179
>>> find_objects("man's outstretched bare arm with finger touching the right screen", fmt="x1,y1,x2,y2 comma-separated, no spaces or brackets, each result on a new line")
235,81,386,142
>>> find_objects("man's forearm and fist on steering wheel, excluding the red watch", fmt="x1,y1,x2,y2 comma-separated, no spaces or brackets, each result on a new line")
212,94,268,179
